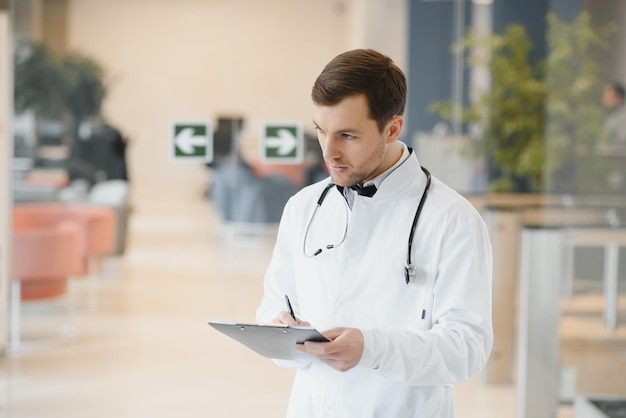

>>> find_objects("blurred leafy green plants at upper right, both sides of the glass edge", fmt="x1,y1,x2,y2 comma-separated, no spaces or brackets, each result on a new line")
430,12,614,192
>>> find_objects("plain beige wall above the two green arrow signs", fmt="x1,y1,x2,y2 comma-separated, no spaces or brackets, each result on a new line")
62,0,400,193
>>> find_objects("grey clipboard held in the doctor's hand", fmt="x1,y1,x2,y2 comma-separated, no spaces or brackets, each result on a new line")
209,320,329,360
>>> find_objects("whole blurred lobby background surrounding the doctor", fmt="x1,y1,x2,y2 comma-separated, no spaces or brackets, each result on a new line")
0,0,626,418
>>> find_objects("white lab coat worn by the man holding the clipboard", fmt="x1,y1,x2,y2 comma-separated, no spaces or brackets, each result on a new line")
257,153,493,418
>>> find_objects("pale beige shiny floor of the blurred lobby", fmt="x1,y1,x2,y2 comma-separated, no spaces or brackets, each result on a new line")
0,187,626,418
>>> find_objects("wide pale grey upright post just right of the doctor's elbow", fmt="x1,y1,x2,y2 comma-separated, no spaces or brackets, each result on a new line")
517,228,563,418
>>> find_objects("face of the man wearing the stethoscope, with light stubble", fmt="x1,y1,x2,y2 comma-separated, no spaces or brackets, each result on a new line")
313,95,403,186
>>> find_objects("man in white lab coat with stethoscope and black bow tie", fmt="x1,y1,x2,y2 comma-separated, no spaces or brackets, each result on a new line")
257,50,493,418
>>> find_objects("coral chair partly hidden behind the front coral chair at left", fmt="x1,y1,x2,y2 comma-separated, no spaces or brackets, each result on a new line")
13,203,117,309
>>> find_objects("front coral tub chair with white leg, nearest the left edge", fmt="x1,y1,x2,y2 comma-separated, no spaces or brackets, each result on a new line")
9,218,84,351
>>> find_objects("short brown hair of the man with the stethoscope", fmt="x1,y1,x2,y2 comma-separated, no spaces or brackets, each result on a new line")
311,49,406,132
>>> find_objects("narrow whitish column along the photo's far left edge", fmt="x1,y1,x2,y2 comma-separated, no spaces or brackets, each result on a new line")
0,4,13,352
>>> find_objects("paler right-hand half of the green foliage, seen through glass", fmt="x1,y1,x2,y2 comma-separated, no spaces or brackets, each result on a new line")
544,13,617,191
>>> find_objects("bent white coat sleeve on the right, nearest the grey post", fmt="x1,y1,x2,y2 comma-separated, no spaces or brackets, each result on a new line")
359,207,493,385
